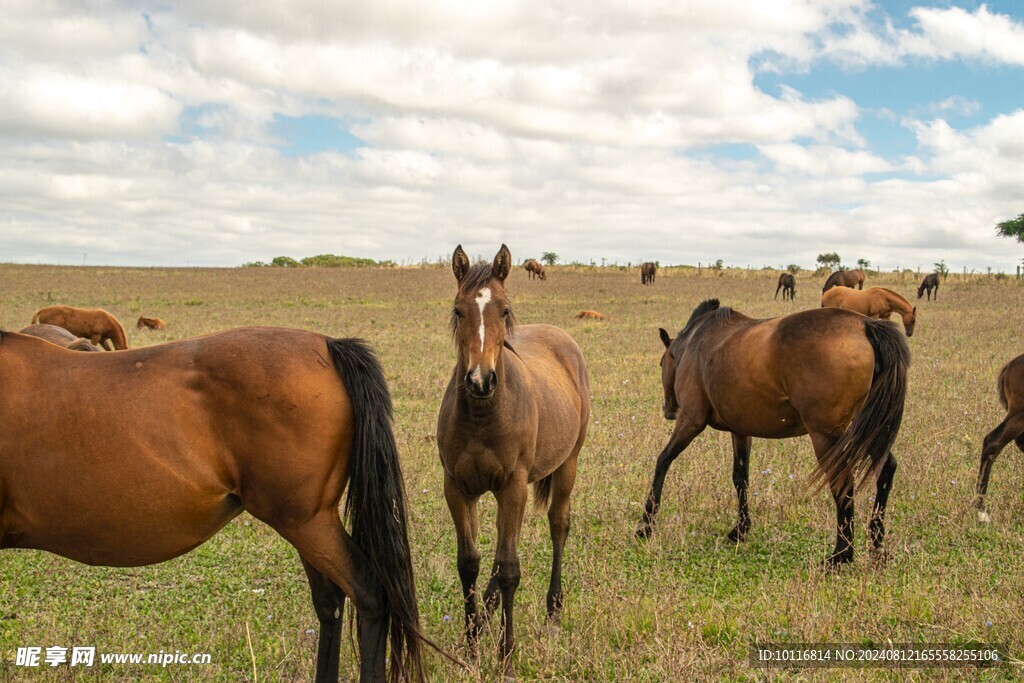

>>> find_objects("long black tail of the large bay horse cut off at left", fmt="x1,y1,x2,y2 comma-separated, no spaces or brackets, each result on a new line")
327,339,425,681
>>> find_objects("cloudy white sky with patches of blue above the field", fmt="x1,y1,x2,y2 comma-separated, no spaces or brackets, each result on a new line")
0,0,1024,271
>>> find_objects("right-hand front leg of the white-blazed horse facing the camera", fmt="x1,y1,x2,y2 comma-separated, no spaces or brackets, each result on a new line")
483,479,527,682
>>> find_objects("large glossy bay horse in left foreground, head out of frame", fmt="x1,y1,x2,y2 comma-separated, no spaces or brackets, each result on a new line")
0,328,429,683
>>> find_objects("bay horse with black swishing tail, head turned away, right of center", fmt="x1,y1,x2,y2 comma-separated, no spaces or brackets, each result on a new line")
636,299,910,570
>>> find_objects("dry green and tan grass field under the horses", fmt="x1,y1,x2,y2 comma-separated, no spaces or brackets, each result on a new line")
0,265,1024,681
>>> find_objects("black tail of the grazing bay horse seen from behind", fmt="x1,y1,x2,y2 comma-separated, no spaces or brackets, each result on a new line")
812,318,910,489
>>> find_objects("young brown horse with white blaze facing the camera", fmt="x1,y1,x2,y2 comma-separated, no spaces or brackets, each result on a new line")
437,245,590,680
